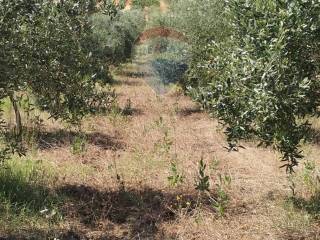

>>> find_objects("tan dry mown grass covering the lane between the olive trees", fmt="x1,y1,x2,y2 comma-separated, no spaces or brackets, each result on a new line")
0,61,320,240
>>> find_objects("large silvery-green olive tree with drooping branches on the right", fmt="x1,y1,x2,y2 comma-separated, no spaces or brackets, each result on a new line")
178,0,320,171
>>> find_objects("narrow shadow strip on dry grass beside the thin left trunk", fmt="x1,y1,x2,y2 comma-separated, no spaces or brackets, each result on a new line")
38,129,125,150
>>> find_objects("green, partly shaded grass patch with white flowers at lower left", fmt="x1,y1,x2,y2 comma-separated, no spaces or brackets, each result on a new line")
0,158,62,232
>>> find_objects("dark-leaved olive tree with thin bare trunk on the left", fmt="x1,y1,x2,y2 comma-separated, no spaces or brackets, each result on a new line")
0,0,114,137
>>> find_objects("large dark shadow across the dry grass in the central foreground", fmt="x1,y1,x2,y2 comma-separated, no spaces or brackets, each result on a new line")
59,185,209,239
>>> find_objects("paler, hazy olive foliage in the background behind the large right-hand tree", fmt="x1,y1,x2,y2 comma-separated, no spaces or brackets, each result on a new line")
152,0,230,87
